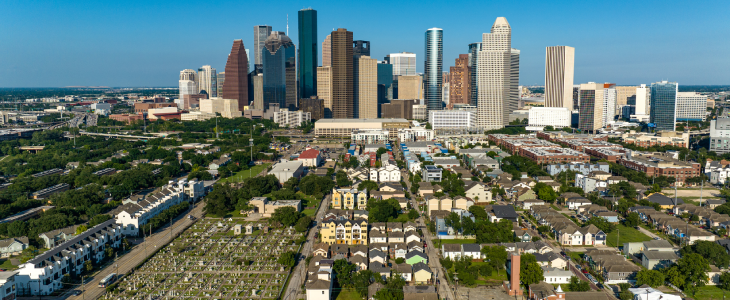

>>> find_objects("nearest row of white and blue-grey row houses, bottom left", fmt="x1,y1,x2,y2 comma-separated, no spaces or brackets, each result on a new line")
16,219,123,295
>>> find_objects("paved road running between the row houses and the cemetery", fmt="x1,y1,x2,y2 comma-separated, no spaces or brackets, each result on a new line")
66,201,205,299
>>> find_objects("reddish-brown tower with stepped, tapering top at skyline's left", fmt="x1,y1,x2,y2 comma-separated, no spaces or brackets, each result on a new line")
222,40,249,111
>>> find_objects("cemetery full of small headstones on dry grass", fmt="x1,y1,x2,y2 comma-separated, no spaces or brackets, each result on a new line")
103,218,303,300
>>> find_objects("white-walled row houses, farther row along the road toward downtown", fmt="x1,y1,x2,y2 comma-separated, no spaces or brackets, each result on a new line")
113,179,204,236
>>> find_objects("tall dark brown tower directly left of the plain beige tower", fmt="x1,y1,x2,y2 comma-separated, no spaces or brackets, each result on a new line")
332,28,354,119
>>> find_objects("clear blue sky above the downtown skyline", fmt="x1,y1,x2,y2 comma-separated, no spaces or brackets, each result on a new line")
0,0,730,87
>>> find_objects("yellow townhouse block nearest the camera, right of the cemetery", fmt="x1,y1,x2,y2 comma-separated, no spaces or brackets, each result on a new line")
319,219,368,245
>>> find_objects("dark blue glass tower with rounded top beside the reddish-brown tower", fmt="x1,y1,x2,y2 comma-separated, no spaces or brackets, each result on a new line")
261,31,298,110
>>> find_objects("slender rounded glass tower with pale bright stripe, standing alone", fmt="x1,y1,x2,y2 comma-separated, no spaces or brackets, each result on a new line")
423,28,444,110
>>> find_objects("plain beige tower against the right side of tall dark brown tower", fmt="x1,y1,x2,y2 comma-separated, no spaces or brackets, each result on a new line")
353,55,378,119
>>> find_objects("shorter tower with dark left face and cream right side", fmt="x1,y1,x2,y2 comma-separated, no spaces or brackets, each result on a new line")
578,82,605,132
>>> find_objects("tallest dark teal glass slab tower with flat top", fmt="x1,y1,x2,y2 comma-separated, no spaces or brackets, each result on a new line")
297,8,319,98
